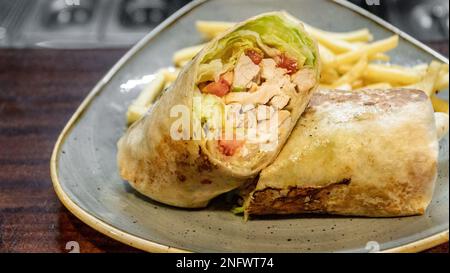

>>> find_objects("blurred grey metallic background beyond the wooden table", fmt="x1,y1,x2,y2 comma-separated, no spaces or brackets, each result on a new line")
0,0,449,55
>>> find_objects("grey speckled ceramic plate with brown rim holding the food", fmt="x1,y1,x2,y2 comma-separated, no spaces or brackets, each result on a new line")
51,0,449,252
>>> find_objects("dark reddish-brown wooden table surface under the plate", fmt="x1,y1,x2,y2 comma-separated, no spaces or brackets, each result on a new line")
0,44,449,252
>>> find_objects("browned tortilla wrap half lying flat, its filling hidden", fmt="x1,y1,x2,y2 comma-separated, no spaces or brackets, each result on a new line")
244,89,438,217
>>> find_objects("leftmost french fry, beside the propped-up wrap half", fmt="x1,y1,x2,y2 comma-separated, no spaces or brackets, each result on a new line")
127,71,165,124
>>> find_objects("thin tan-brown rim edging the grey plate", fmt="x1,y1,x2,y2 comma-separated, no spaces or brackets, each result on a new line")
50,0,449,253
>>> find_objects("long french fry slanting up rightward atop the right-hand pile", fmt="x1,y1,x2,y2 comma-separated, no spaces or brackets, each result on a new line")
328,35,398,67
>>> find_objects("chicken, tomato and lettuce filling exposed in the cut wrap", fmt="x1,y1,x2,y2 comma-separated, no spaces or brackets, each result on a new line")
194,14,318,169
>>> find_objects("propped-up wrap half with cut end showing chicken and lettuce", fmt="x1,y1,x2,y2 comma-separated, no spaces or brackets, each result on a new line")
118,12,319,208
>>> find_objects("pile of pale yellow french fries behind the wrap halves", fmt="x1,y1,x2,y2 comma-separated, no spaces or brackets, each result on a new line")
127,21,449,124
